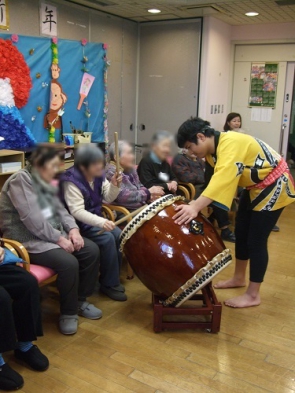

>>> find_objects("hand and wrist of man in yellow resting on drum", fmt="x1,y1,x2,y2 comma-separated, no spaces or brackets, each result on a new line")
172,195,213,225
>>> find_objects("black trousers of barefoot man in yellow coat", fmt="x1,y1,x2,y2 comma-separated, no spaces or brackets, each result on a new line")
235,190,283,283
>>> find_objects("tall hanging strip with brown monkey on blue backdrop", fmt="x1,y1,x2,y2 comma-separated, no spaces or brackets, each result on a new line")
44,37,68,143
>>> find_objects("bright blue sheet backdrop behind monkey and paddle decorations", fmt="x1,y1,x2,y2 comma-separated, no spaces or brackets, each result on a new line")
0,34,107,142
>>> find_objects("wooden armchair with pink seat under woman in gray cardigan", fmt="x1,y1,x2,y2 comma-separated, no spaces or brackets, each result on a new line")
3,239,57,287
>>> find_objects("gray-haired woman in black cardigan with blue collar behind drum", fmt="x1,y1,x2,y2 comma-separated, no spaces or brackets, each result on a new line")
137,131,177,194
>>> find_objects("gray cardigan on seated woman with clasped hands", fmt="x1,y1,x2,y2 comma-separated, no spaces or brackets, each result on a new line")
0,169,78,254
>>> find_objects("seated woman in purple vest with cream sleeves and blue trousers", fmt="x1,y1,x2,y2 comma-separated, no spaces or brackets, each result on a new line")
60,144,127,301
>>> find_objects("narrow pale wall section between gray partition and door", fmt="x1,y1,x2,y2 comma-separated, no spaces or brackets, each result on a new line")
199,17,232,129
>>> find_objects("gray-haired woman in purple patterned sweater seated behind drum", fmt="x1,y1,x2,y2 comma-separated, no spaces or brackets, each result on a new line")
106,141,164,211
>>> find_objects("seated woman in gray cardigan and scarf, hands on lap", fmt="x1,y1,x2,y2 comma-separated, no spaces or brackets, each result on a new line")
0,147,102,334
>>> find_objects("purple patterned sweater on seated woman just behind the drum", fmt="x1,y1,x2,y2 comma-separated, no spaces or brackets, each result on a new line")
106,162,151,210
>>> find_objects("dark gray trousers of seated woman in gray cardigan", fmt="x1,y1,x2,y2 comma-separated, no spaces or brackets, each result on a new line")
30,239,99,315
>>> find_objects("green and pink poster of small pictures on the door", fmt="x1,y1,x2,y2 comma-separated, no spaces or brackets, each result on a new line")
249,63,278,108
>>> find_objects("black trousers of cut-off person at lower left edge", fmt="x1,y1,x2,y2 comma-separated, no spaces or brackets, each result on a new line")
0,265,43,353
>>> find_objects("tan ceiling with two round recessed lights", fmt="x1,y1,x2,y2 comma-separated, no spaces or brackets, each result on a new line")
67,0,295,25
